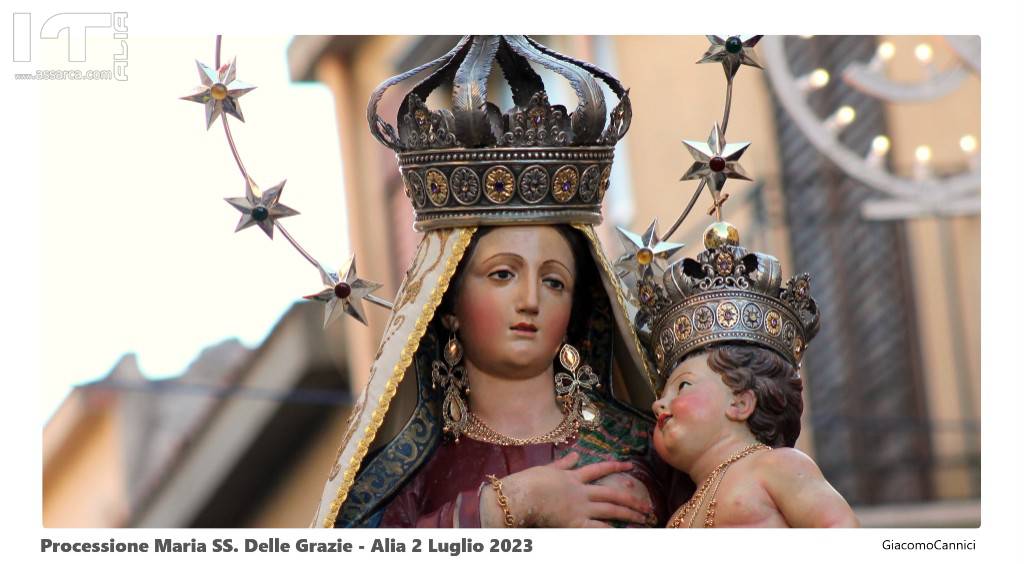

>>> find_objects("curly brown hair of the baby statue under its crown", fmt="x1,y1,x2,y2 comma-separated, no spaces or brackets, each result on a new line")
706,344,804,446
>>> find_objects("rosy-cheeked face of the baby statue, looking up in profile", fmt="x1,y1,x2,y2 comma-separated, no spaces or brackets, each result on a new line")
651,353,733,470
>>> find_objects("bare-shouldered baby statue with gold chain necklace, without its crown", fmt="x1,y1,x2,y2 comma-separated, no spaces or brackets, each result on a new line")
652,344,859,527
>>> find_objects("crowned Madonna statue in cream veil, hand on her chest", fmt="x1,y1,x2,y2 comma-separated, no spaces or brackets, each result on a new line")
313,36,689,527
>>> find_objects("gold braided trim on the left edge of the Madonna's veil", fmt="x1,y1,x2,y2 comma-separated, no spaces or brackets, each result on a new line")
323,227,476,528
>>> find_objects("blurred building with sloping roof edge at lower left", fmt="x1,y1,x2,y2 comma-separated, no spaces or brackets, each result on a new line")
43,303,352,527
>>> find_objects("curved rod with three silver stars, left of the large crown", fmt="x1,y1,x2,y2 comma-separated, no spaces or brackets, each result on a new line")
181,35,393,329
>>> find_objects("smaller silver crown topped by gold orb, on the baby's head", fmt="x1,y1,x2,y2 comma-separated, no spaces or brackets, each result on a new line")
636,221,821,376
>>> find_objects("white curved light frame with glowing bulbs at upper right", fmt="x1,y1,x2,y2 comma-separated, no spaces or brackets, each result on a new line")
761,36,981,219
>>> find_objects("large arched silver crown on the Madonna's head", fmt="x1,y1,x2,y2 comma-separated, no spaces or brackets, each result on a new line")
367,35,632,231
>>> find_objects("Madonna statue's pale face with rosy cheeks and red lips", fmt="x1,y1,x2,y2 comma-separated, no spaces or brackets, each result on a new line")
455,225,575,378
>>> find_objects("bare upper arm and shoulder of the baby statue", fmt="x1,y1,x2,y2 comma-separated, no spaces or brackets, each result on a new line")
759,447,860,527
